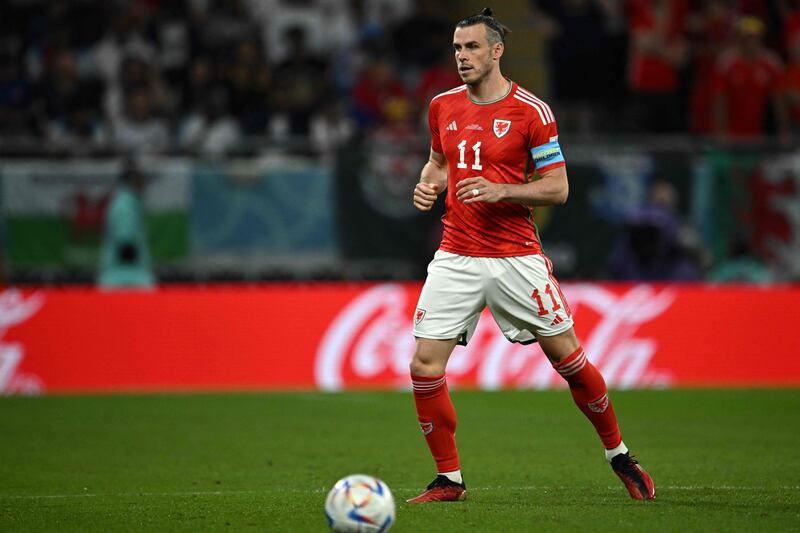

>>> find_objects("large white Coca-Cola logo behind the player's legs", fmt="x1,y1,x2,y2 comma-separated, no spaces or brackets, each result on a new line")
314,284,675,391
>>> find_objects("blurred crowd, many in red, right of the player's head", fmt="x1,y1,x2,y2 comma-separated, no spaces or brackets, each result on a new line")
534,0,800,140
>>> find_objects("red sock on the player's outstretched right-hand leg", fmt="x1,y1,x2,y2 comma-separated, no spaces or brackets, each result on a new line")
553,347,622,450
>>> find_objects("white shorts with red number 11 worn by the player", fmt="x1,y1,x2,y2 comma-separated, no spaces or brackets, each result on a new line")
414,250,572,344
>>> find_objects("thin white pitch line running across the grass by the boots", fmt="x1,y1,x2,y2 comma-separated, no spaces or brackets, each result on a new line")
0,485,800,500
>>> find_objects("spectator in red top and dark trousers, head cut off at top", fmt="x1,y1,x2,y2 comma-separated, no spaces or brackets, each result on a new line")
628,0,688,133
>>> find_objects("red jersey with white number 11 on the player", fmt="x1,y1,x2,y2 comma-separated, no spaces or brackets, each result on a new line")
428,82,565,257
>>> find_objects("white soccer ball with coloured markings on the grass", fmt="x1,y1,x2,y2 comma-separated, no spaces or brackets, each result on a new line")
325,474,395,533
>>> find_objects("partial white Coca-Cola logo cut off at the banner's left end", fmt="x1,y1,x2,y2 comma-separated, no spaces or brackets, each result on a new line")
0,289,44,394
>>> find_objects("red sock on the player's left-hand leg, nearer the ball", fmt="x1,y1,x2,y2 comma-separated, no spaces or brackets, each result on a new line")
411,374,461,472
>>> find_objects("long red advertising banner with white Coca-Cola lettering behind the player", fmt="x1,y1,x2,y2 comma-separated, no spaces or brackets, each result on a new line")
0,283,800,394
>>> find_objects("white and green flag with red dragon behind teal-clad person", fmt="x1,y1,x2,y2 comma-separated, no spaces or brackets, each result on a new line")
0,158,191,269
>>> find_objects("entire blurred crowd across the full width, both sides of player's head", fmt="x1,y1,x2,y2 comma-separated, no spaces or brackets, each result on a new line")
0,0,800,156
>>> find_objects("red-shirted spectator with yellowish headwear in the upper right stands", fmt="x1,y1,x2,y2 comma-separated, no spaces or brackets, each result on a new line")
714,17,788,139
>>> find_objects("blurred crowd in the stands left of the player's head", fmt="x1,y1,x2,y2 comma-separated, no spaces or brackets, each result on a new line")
0,0,460,155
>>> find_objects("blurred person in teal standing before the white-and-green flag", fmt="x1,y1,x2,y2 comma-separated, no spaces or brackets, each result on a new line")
98,164,155,288
